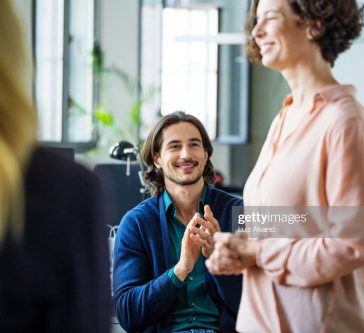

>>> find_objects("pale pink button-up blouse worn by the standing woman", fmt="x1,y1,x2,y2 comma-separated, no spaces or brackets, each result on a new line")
237,85,364,333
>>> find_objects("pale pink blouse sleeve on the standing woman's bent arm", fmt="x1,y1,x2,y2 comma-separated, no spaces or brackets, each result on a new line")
257,105,364,287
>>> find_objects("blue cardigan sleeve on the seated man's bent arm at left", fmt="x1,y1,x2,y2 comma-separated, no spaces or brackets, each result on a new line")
113,211,179,332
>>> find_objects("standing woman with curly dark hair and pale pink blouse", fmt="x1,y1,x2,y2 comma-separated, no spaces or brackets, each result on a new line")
206,0,364,333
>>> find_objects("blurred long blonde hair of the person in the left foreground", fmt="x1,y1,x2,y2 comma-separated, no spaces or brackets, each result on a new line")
0,0,37,244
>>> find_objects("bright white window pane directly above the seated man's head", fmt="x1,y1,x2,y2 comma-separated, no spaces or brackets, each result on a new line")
161,8,219,139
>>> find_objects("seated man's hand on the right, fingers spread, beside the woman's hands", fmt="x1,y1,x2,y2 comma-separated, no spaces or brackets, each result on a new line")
191,205,220,258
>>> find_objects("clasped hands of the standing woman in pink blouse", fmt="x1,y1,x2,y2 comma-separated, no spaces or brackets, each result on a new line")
206,232,259,275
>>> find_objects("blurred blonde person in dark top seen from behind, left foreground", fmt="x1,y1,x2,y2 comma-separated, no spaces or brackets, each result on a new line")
0,0,110,333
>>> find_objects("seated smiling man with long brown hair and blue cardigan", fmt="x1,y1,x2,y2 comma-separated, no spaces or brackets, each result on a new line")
113,111,242,333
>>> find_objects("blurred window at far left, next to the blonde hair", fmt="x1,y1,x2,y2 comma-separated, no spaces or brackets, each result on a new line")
35,0,96,147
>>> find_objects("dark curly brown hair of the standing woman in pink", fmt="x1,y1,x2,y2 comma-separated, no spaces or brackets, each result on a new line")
245,0,364,66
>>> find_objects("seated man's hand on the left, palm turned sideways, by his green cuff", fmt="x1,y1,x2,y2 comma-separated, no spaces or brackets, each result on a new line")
174,213,201,281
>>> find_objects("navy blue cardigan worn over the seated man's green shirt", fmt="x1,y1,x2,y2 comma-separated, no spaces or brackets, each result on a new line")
113,187,243,333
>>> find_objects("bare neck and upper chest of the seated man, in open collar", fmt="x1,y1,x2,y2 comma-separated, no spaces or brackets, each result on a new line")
166,178,204,225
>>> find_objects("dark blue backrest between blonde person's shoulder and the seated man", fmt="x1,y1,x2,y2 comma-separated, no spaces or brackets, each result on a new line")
94,163,143,226
